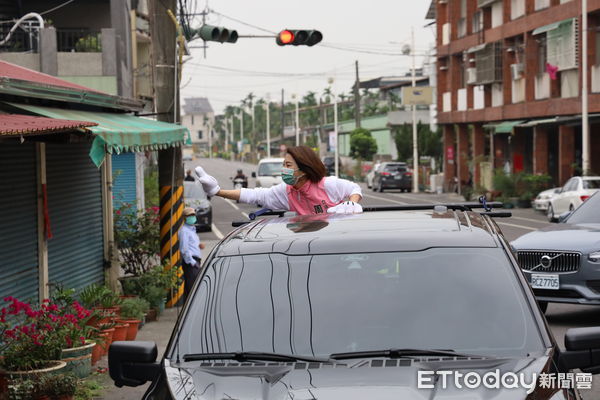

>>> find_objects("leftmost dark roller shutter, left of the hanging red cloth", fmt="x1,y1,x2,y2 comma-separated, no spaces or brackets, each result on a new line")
0,143,39,302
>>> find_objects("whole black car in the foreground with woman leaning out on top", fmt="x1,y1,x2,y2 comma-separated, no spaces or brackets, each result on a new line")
109,205,600,400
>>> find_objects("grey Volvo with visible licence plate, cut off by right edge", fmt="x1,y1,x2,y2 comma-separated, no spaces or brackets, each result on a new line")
511,193,600,310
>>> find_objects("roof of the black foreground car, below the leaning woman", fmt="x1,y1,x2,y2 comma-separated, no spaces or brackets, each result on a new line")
215,210,499,257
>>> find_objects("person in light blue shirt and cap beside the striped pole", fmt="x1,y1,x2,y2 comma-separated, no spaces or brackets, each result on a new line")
179,207,204,301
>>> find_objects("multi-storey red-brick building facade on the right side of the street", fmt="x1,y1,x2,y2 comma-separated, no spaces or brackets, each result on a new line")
430,0,600,191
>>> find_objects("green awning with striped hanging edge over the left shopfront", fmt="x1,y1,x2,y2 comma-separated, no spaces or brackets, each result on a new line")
9,103,189,167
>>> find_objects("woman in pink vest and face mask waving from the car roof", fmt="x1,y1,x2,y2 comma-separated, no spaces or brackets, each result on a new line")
196,146,362,215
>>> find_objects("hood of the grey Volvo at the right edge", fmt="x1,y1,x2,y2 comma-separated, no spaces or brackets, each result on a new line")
511,223,600,253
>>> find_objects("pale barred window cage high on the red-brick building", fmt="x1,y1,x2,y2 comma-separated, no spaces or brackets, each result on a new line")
546,18,579,71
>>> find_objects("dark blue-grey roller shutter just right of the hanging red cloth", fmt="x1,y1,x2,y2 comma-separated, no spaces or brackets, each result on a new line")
46,143,104,289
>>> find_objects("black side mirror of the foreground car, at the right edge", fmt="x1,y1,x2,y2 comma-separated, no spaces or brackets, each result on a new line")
559,327,600,374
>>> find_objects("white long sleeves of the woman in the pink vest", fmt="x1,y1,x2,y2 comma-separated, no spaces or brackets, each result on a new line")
240,176,362,210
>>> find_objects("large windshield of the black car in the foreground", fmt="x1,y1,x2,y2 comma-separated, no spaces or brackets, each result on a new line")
172,248,543,357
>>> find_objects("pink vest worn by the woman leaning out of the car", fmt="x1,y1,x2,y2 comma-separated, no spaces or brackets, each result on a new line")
286,178,337,215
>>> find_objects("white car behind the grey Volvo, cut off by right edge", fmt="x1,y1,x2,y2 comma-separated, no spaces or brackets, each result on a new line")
546,176,600,222
